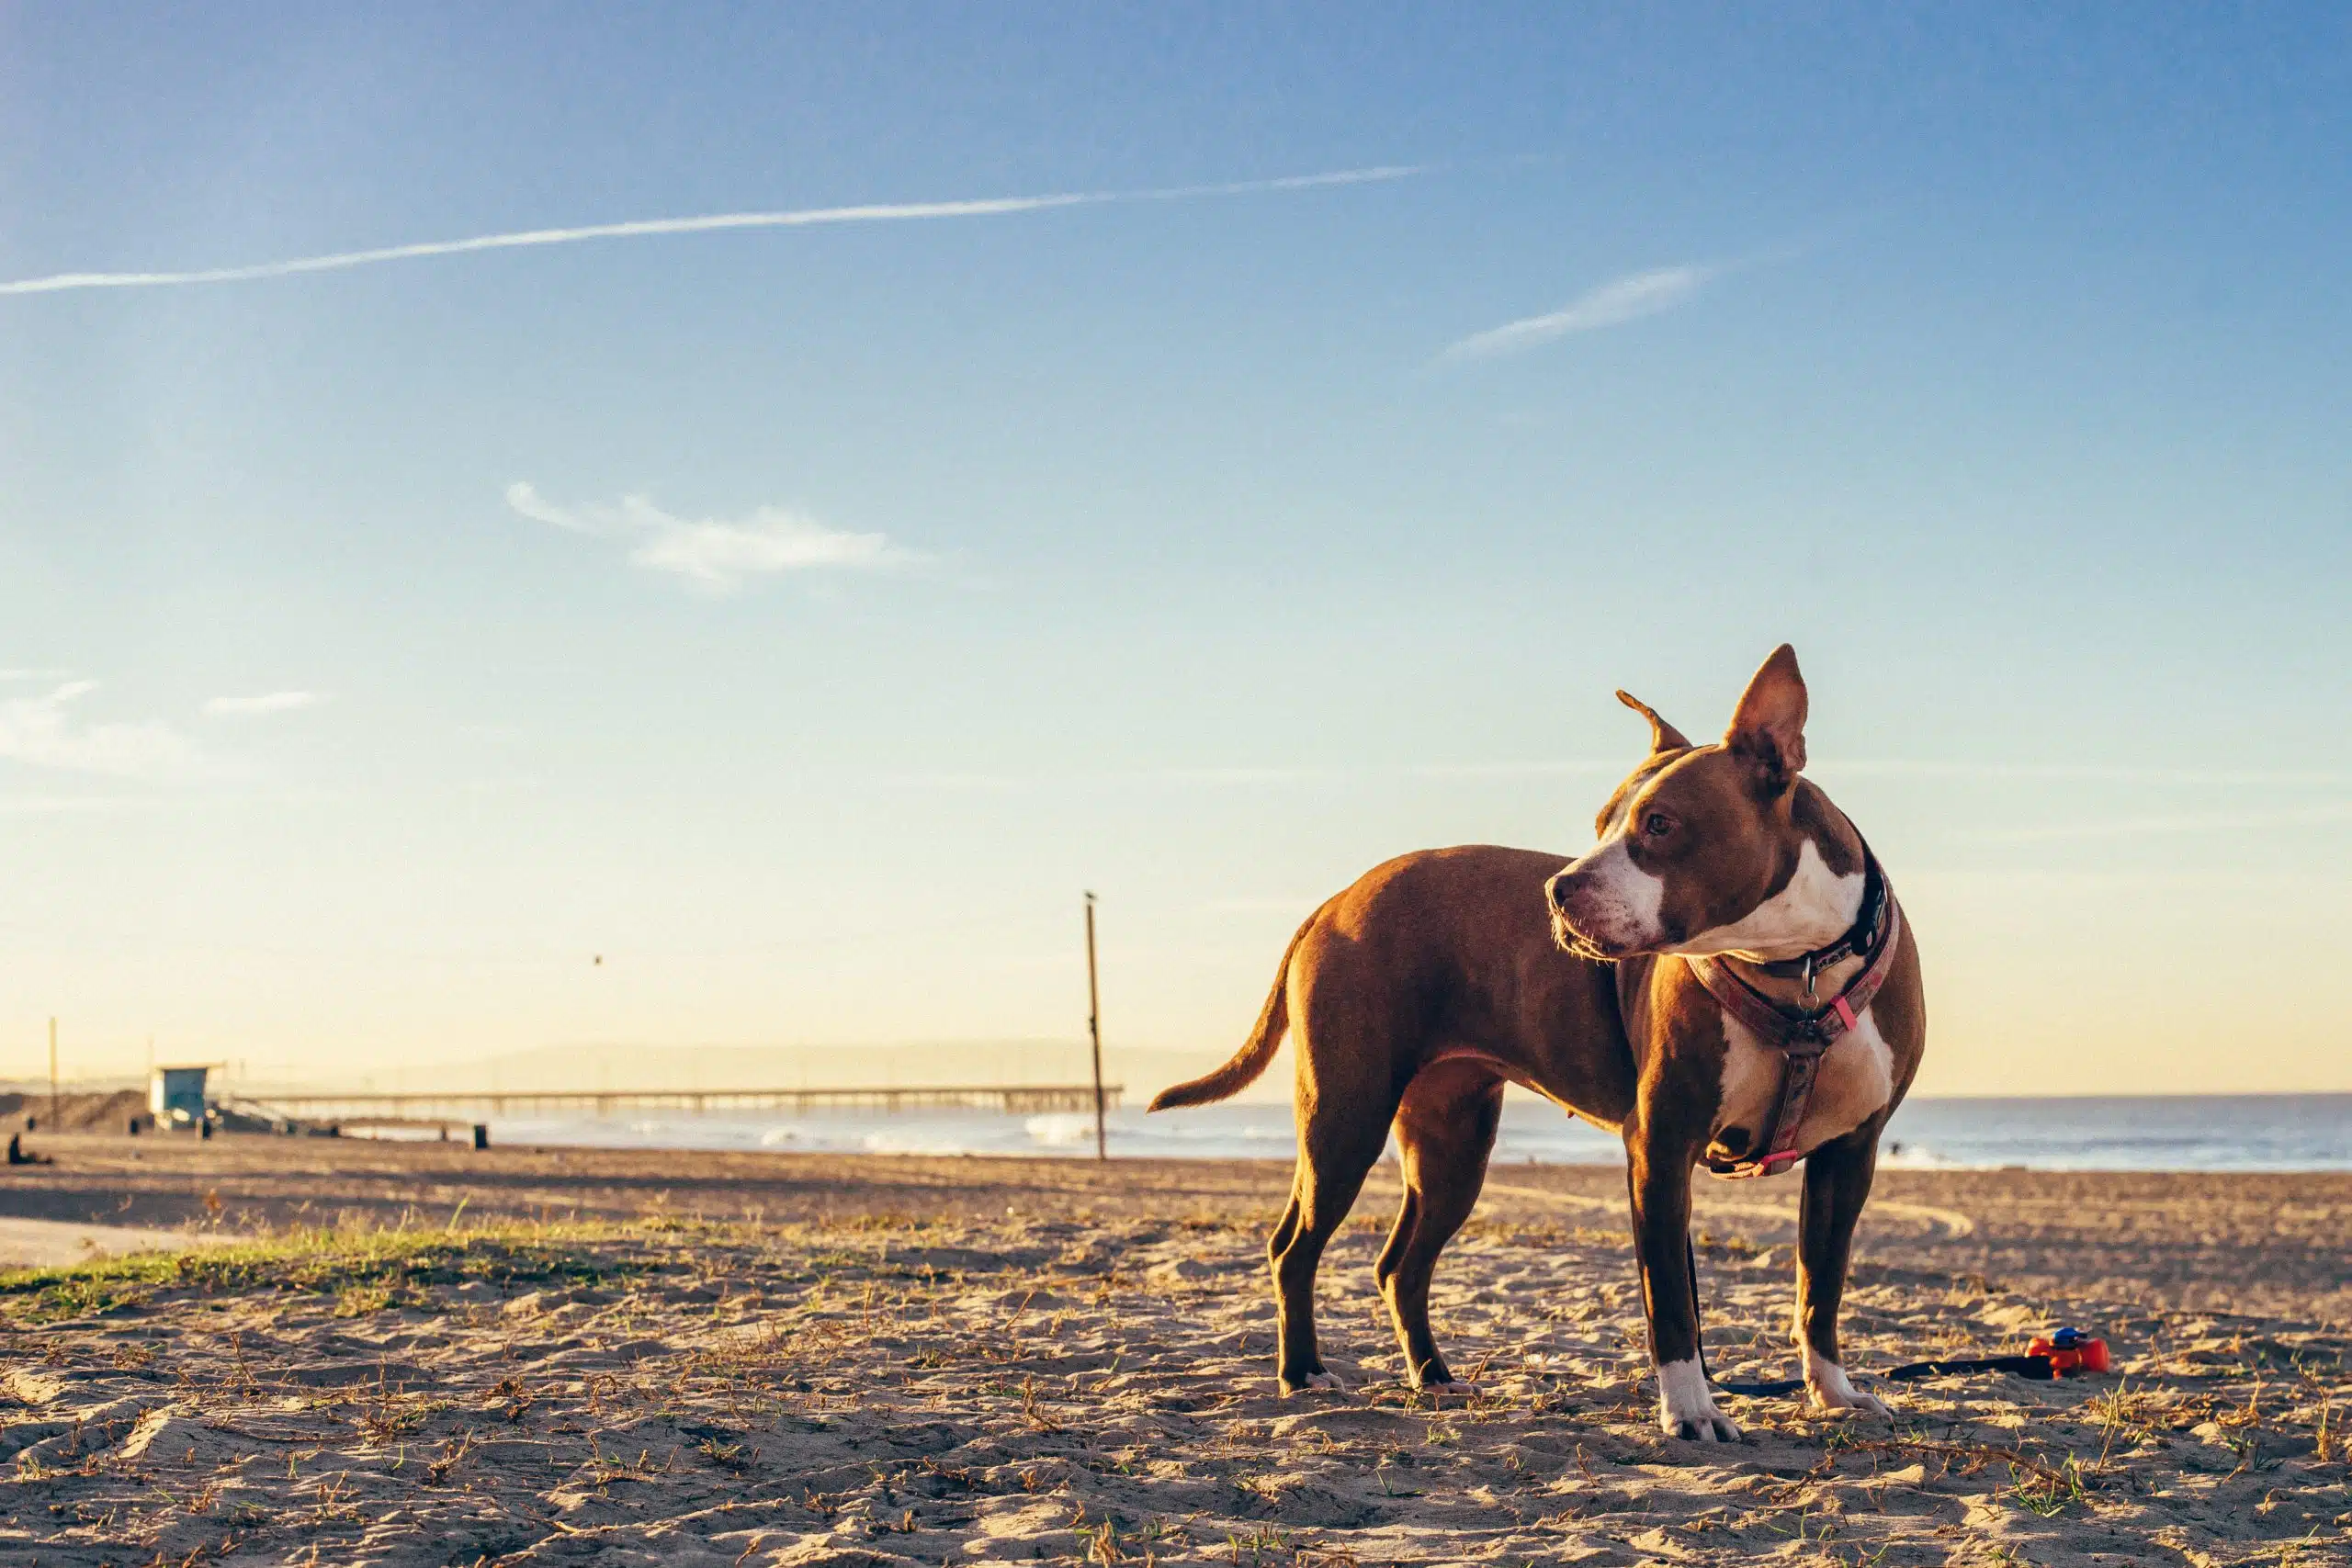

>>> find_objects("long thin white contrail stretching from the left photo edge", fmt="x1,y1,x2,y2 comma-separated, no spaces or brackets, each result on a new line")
0,164,1428,294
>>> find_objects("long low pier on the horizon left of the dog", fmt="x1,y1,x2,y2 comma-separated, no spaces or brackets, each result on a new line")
238,1084,1120,1122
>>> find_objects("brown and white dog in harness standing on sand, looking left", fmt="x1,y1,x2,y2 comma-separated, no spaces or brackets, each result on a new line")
1152,647,1927,1441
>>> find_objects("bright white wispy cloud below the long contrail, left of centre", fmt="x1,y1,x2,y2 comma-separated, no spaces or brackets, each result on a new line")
505,479,932,592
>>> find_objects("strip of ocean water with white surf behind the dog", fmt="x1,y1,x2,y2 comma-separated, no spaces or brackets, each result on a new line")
489,1096,2352,1170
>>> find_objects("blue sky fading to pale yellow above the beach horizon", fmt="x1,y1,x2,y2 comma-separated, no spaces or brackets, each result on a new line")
0,5,2352,1090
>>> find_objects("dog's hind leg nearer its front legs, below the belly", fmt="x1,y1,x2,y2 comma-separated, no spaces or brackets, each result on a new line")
1374,1060,1503,1392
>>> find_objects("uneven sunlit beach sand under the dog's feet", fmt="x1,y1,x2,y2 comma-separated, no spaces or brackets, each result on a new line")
0,1138,2352,1568
